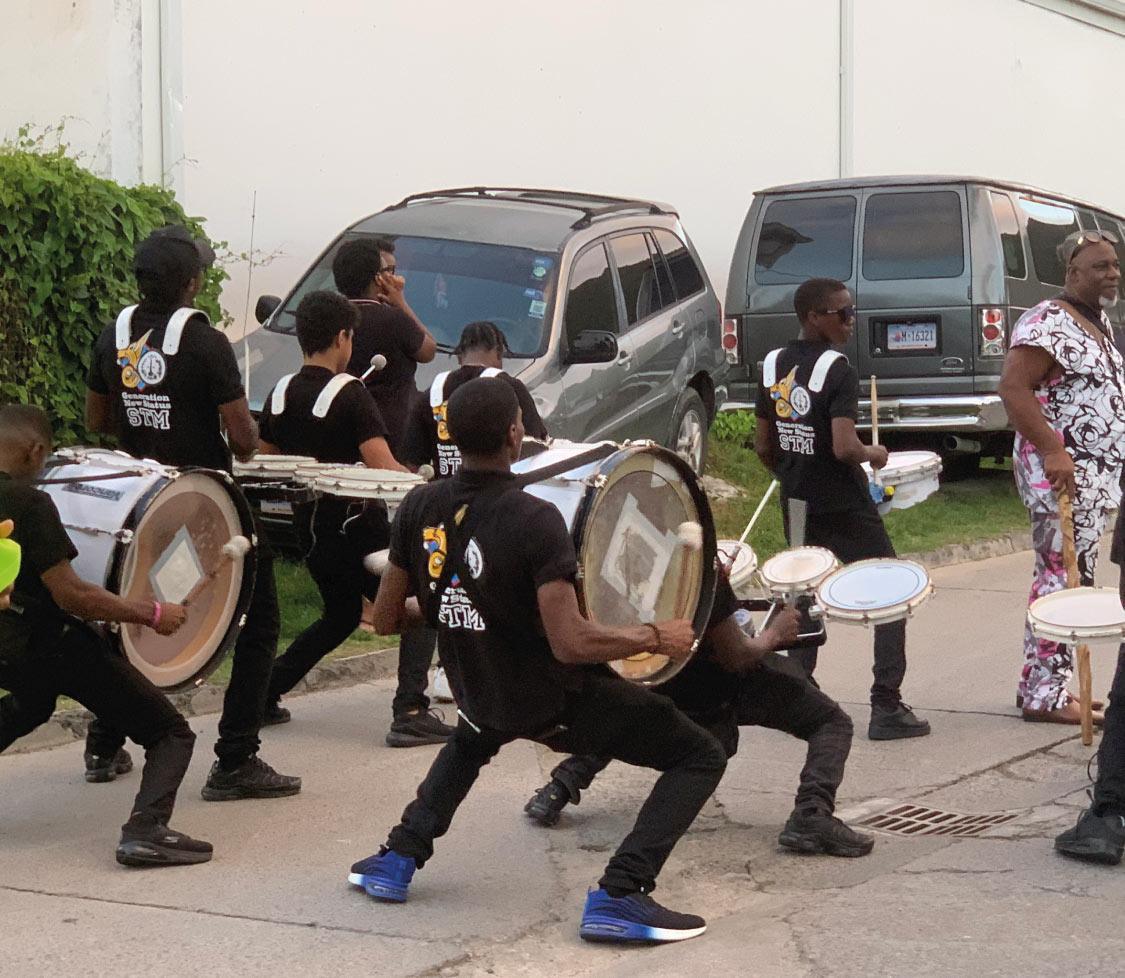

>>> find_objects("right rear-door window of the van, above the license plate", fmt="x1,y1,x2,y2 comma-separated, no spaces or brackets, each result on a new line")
863,190,965,281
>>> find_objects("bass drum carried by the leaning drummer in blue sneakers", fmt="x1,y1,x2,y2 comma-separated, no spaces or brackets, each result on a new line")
512,442,716,685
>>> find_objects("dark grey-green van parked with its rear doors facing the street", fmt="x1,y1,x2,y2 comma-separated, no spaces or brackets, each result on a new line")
723,177,1125,470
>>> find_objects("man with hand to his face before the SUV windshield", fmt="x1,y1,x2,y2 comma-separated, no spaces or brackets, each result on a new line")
332,237,438,458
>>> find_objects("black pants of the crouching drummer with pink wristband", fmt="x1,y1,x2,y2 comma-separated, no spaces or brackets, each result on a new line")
0,625,196,824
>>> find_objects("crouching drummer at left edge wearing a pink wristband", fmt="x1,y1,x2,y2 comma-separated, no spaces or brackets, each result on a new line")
0,405,212,865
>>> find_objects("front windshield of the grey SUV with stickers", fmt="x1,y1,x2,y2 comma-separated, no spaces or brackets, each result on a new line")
269,234,558,357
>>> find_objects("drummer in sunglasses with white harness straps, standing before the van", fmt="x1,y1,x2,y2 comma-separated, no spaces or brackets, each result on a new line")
755,278,929,741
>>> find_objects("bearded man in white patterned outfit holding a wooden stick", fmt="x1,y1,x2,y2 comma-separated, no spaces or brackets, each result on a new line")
1000,225,1125,724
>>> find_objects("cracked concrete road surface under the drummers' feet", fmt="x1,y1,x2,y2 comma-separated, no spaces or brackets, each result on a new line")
0,544,1125,978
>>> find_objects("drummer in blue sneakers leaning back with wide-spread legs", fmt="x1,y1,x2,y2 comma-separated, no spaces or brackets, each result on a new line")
349,378,726,942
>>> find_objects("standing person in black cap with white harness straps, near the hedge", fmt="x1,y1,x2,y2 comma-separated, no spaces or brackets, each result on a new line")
86,225,300,801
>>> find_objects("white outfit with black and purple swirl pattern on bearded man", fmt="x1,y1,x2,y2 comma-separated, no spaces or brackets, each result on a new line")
1011,299,1125,710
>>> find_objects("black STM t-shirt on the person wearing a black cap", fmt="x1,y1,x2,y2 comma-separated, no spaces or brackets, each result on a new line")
86,306,245,472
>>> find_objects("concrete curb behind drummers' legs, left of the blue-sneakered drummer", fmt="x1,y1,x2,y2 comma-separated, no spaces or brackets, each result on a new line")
5,646,398,754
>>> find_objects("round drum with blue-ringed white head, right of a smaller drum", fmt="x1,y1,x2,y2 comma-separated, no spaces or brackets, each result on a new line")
817,557,934,625
